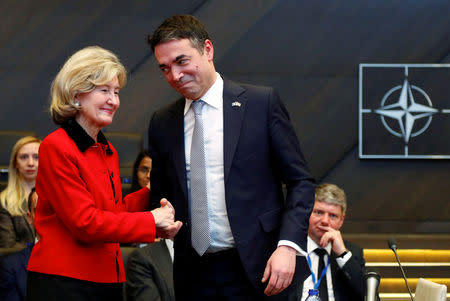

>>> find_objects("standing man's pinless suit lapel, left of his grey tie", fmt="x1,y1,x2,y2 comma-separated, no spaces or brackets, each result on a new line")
170,98,188,200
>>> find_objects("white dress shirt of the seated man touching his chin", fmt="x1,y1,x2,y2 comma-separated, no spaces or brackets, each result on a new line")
301,235,352,301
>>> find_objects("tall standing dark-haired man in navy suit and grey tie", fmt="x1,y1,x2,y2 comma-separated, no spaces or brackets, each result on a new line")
149,15,315,301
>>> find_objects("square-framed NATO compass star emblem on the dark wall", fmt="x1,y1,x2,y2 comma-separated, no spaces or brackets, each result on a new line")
359,64,450,159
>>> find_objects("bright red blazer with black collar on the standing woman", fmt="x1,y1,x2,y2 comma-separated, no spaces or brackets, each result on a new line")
28,121,156,283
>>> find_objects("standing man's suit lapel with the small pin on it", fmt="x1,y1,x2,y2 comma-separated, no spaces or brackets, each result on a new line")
223,79,246,182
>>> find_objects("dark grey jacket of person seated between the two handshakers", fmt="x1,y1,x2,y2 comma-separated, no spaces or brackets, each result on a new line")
125,240,175,301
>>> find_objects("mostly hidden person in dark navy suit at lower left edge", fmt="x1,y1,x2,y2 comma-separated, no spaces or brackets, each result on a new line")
0,188,38,301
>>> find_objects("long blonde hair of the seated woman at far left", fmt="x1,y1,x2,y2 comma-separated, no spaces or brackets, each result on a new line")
0,136,41,215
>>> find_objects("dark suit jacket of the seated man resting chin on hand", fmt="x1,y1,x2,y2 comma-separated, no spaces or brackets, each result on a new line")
289,241,366,301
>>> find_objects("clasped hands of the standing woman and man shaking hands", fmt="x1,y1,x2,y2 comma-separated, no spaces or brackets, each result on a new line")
151,199,183,238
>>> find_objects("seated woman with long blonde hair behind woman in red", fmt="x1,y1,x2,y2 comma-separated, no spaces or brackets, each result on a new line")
0,136,41,248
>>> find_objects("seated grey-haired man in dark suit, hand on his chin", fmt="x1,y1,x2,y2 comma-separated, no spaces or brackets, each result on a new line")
289,183,366,301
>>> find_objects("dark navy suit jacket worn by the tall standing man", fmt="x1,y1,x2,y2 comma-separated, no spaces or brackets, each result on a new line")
149,80,315,296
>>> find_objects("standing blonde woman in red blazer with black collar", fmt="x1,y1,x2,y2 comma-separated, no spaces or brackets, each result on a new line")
28,46,181,301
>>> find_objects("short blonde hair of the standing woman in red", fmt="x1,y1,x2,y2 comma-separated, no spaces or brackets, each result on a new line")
50,46,127,124
